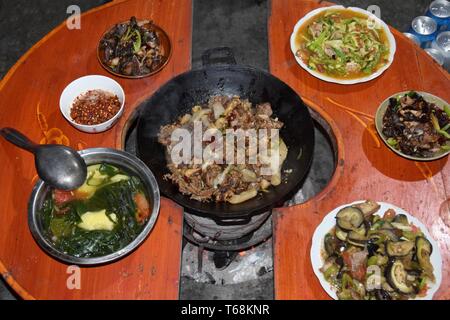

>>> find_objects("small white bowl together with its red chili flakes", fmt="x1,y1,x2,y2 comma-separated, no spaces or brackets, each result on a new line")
59,75,125,133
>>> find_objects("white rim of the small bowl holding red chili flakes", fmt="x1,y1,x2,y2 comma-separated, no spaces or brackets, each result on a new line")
59,74,125,132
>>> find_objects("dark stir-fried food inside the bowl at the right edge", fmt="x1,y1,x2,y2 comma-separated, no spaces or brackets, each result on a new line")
382,91,450,158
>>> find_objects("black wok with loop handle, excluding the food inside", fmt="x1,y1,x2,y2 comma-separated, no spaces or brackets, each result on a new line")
136,48,314,220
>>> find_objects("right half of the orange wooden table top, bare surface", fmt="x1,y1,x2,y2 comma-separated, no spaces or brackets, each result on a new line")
269,0,450,299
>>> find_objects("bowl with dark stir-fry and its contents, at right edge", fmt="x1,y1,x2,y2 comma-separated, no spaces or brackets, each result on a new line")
375,91,450,161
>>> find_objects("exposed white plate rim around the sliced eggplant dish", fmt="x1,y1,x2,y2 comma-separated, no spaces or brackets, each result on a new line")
311,200,442,300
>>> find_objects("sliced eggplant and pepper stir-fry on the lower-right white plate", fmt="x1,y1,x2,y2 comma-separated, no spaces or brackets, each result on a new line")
321,200,435,300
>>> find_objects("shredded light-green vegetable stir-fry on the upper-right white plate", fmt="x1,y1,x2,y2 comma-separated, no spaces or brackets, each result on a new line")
296,9,389,79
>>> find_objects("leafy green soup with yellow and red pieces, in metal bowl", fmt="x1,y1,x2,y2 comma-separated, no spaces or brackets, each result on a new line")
42,163,150,258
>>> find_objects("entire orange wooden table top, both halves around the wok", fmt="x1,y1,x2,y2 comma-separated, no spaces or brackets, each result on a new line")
0,0,450,299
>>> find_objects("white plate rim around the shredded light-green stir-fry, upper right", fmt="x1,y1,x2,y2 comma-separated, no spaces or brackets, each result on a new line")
290,6,396,84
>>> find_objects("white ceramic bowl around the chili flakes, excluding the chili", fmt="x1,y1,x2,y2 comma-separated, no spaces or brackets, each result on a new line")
59,75,125,133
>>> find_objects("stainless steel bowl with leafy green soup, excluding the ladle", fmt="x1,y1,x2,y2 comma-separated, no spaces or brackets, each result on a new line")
28,148,160,265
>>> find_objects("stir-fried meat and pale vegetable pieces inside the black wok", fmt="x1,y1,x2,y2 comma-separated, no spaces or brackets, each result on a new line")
158,96,288,203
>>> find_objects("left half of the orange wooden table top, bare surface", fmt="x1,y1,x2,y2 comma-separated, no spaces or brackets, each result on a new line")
0,0,192,299
